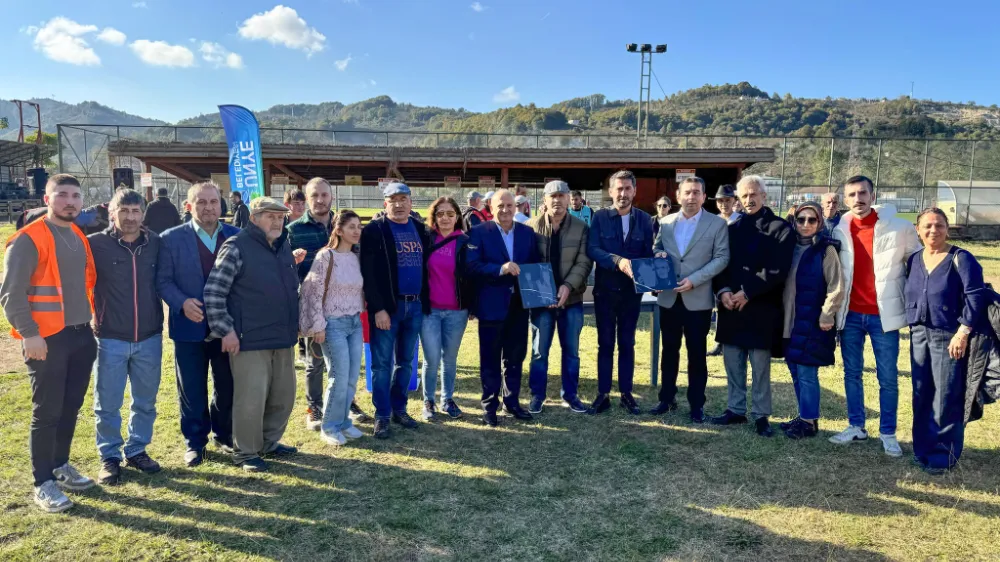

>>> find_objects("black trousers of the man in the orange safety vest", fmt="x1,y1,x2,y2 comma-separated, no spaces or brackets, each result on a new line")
25,324,97,486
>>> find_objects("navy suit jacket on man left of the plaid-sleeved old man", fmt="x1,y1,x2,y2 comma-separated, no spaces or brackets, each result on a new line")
156,221,240,343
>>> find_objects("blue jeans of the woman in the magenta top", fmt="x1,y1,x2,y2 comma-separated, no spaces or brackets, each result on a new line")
420,308,469,403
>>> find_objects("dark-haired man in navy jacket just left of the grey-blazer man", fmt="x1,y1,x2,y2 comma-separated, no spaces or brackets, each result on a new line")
587,170,653,415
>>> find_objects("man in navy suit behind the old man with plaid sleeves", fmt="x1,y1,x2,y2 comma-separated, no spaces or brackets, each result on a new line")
156,182,240,467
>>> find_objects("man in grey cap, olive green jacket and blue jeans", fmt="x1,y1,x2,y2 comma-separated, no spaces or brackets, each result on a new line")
528,180,594,414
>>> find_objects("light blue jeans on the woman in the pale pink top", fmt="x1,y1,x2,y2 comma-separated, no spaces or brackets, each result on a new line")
320,314,365,428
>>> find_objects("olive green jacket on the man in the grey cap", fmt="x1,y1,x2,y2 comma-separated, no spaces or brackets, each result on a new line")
528,213,594,305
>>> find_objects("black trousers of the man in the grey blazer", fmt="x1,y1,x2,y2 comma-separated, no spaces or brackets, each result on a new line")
659,295,712,410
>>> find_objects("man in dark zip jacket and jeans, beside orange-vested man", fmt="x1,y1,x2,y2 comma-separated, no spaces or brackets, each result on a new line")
87,189,163,485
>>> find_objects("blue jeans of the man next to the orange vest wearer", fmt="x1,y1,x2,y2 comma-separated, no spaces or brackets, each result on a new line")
94,334,163,460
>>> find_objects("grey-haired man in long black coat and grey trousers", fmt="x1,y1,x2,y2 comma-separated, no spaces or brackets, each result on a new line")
711,176,795,437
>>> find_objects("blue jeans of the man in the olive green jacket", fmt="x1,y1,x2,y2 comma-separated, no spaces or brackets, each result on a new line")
528,303,583,400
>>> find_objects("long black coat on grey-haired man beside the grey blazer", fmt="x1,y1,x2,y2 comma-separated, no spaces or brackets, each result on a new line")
712,207,795,357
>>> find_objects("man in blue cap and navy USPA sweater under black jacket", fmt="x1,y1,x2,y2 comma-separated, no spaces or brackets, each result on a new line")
361,183,430,439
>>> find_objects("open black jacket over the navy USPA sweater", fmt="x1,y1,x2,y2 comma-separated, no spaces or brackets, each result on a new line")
361,215,430,318
